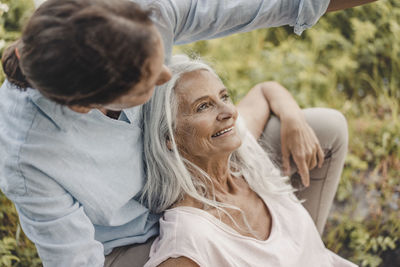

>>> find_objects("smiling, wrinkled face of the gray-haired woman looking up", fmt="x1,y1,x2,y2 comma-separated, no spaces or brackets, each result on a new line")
175,70,241,163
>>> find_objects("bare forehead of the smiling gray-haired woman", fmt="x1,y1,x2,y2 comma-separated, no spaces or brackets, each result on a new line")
175,69,224,103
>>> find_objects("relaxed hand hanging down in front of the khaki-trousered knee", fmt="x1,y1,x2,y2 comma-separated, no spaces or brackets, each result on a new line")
280,113,324,187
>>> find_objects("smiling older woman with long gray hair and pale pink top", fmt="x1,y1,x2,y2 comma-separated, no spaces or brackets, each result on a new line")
142,56,355,267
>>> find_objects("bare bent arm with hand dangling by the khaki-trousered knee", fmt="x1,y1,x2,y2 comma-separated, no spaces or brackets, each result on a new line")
238,82,324,186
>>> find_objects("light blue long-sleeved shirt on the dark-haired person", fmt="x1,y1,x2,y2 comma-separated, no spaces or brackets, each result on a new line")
0,0,329,267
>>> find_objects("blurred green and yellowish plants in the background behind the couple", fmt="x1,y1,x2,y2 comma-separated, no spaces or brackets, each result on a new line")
0,0,400,267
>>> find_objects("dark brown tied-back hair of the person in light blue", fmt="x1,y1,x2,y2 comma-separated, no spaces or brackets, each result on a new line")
2,0,157,106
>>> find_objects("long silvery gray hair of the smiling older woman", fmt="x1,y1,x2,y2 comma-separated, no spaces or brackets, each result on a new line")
142,55,293,216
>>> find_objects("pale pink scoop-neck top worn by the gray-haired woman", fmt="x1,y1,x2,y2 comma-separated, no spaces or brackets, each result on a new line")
145,195,356,267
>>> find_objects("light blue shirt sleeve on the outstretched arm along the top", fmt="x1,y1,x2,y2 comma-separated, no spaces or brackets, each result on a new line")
158,0,329,44
